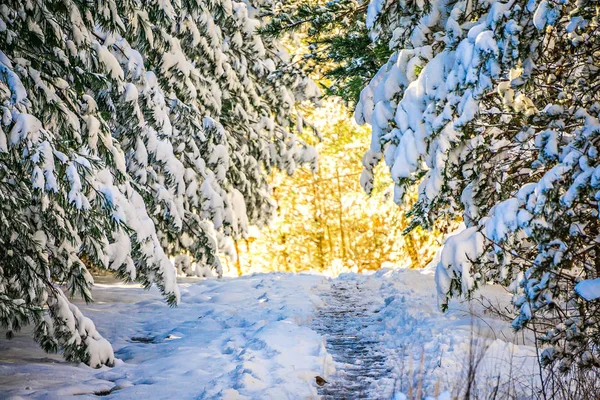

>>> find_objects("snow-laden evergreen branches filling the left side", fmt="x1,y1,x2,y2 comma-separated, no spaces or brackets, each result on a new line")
0,0,319,366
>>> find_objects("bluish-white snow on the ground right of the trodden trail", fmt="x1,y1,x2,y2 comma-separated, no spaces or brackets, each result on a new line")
338,269,538,399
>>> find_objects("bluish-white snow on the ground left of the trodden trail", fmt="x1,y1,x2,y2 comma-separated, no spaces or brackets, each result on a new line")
0,274,327,399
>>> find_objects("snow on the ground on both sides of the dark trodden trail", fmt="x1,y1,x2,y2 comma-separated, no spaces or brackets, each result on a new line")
0,270,536,399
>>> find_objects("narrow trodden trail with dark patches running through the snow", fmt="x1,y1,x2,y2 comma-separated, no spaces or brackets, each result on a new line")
312,280,394,400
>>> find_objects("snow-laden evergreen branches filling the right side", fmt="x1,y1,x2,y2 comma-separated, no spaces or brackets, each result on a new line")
355,0,600,370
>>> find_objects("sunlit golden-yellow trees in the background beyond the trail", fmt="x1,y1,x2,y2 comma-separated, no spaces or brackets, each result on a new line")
238,98,447,274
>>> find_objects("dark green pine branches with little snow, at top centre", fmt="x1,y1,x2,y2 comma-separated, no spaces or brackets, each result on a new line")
261,0,391,104
